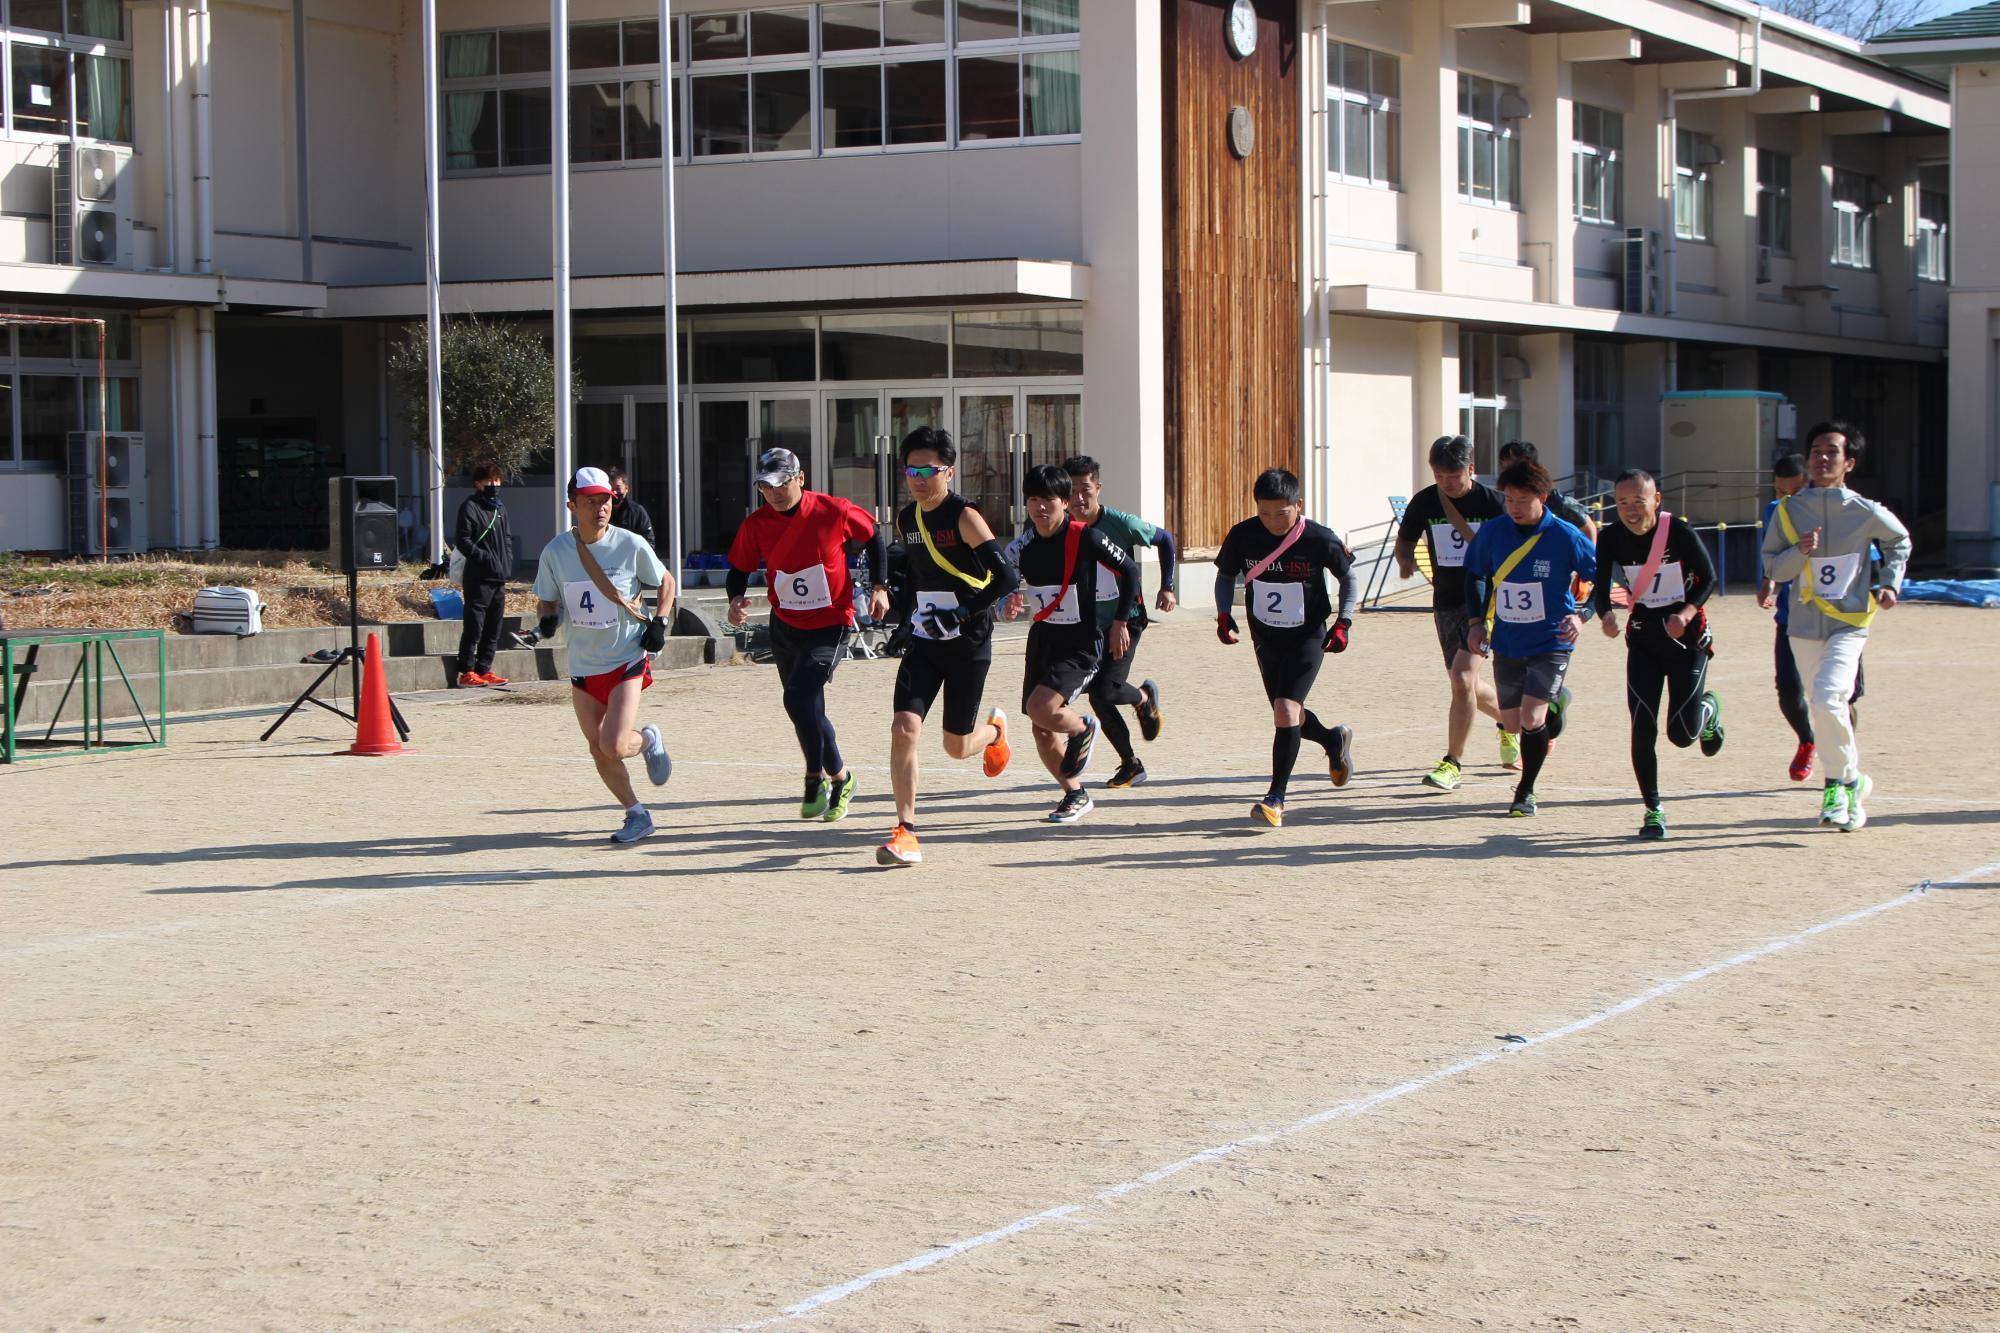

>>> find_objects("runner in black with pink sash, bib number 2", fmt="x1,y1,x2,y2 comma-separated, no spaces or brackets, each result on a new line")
1216,468,1360,829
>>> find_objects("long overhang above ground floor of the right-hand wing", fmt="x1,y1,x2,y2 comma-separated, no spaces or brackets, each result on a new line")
1326,284,1944,362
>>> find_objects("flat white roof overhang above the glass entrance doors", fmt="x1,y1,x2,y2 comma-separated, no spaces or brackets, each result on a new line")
318,258,1090,320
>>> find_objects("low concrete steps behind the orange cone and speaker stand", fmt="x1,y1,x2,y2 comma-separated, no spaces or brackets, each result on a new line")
1,616,712,720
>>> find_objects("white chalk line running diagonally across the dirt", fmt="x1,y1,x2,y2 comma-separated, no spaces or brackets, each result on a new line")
730,861,2000,1333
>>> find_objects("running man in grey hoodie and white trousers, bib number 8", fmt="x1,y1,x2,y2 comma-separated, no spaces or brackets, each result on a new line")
1764,420,1910,833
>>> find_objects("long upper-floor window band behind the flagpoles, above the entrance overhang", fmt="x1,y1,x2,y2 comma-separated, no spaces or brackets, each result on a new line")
448,0,1084,172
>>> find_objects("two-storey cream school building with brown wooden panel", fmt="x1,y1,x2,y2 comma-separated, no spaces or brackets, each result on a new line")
0,0,1968,556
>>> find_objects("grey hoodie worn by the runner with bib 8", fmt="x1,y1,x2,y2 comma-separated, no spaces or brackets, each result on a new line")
1764,486,1910,638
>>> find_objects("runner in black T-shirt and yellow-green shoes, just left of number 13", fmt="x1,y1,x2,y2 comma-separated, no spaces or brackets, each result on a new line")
1396,434,1520,791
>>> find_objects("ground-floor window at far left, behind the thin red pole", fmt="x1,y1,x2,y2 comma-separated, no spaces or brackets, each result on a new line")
0,308,138,472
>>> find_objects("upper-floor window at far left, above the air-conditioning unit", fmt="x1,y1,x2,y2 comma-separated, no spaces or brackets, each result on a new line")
4,0,132,144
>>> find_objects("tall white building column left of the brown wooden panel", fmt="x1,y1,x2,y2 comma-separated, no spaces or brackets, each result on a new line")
1082,4,1166,516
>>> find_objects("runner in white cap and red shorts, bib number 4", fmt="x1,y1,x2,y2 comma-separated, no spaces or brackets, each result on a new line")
534,468,674,845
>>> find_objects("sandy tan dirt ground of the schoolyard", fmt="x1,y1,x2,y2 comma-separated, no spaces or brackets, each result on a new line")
0,598,2000,1333
